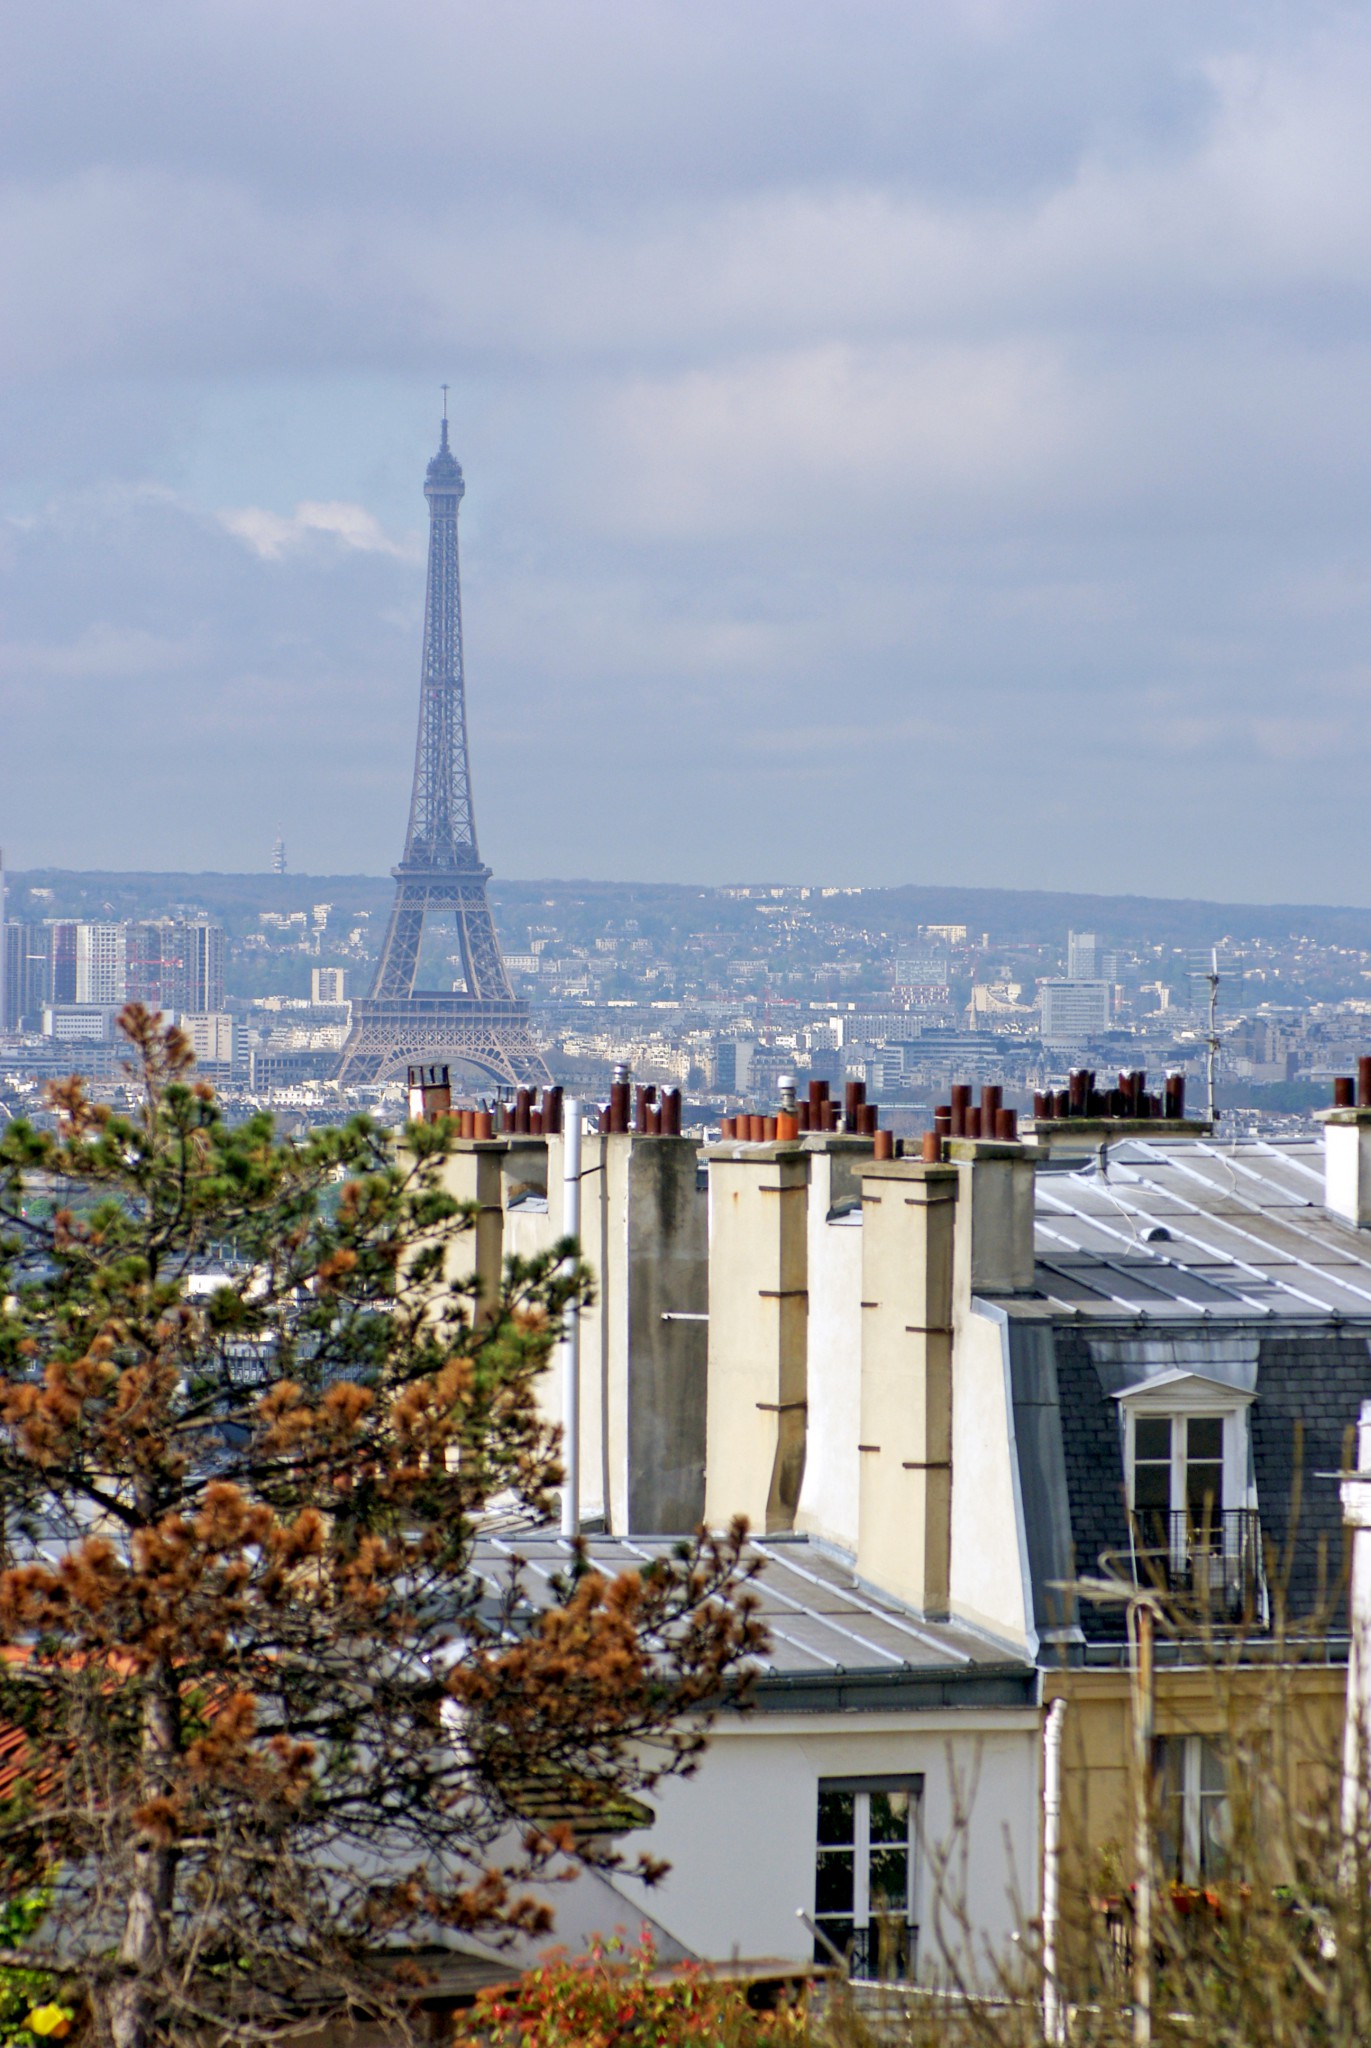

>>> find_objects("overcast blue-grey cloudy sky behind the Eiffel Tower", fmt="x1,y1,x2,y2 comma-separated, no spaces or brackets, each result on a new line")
0,0,1371,903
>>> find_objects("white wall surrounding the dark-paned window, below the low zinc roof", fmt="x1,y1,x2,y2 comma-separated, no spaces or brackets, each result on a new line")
617,1708,1039,1978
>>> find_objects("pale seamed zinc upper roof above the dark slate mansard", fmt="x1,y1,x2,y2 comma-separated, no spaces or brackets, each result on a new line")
1035,1139,1371,1323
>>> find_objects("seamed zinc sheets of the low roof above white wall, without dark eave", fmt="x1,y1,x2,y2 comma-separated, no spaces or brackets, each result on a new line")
473,1530,1006,1681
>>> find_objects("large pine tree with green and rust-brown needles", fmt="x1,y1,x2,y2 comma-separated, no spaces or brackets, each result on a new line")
0,1008,760,2048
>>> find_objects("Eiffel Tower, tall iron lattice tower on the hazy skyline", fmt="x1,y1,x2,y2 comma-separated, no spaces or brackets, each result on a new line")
338,405,549,1085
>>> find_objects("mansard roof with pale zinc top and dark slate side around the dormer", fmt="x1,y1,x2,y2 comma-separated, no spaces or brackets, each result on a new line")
1000,1139,1371,1659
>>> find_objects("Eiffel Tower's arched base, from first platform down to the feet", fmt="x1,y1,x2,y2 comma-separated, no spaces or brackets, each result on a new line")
338,989,551,1087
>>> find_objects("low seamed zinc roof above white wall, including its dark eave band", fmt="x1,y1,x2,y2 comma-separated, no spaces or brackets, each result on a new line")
465,1530,1033,1710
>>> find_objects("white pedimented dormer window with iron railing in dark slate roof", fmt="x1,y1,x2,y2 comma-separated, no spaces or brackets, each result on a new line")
1115,1370,1262,1618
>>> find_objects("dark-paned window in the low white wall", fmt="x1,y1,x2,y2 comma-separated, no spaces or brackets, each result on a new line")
814,1778,922,1982
